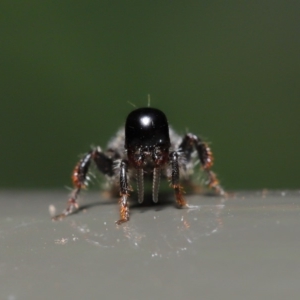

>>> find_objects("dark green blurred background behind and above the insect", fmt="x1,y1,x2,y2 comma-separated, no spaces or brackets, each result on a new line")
0,0,300,189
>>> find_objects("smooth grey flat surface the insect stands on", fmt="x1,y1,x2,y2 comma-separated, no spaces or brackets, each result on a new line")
0,191,300,300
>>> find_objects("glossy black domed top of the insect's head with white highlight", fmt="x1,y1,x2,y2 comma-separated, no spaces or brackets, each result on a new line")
125,107,170,151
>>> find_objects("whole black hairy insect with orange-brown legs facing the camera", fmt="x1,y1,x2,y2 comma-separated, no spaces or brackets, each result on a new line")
54,107,225,225
